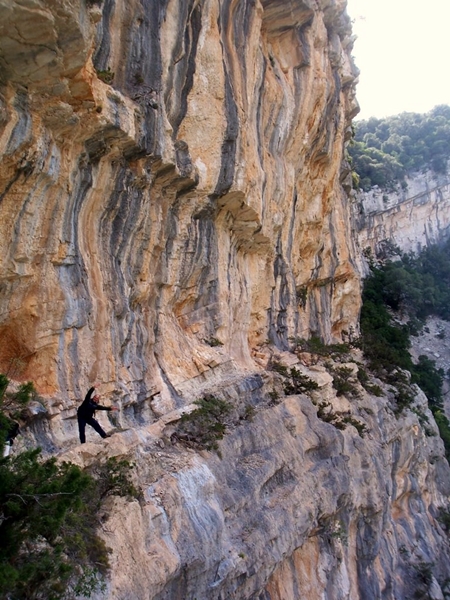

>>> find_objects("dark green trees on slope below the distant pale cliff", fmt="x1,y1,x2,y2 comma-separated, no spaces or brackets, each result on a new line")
361,241,450,460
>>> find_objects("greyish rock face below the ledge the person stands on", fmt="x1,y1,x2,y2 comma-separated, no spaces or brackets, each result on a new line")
59,353,450,600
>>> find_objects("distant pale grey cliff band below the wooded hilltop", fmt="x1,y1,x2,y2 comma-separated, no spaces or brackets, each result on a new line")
356,171,450,255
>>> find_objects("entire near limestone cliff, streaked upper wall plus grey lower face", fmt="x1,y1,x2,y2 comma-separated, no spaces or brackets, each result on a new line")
0,0,449,600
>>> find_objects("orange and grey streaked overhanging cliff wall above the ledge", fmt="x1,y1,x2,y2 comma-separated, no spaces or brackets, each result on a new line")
0,0,359,412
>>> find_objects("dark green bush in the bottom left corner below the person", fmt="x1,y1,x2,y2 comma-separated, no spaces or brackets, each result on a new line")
0,450,98,599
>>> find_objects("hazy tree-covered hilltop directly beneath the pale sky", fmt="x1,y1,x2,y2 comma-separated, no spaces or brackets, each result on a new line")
349,105,450,191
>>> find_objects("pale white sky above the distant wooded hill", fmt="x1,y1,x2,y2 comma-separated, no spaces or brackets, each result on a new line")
347,0,450,119
